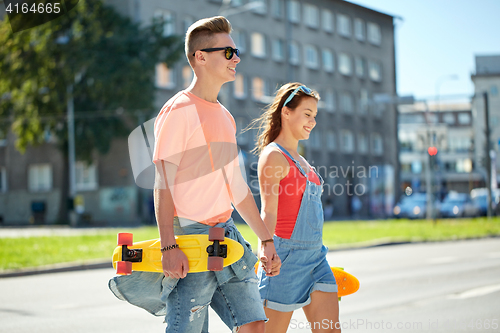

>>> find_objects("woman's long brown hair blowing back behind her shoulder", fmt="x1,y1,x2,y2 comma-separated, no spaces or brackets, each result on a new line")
244,82,320,155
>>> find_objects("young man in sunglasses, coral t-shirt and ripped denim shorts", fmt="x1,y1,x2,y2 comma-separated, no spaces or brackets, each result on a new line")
110,16,281,333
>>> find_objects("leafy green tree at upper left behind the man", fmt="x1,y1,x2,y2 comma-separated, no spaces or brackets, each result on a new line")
0,0,183,161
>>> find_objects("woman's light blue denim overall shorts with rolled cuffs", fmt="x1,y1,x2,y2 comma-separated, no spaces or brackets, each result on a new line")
257,142,337,312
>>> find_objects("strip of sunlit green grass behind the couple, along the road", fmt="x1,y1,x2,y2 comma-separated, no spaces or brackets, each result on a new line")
0,217,500,270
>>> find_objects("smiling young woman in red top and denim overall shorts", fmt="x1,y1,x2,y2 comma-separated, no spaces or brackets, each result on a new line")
253,83,340,333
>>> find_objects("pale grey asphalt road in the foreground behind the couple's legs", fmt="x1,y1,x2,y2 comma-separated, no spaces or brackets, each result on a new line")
0,238,500,333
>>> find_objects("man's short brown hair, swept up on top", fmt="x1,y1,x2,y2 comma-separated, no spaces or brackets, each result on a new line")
184,16,231,67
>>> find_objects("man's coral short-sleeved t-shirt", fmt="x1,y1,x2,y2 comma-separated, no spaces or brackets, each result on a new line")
153,91,241,225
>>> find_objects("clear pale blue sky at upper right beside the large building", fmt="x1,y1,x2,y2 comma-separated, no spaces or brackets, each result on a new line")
349,0,500,101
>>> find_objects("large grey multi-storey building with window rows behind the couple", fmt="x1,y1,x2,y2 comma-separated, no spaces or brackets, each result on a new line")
0,0,399,222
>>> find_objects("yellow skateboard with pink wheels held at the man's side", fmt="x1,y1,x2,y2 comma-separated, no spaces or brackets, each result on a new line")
113,228,243,275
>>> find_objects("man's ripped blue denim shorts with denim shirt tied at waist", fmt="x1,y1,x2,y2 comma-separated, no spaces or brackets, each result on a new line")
109,218,267,333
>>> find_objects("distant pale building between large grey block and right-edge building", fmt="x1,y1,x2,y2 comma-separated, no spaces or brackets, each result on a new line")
398,102,484,200
